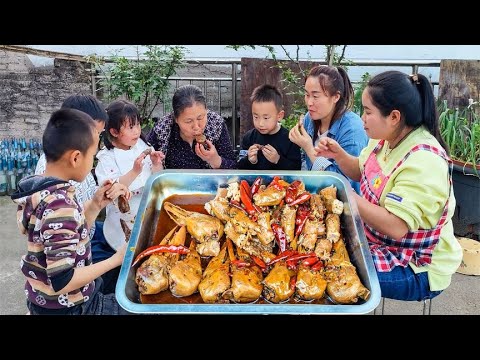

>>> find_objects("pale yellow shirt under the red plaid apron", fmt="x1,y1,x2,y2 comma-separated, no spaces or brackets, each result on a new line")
359,126,463,291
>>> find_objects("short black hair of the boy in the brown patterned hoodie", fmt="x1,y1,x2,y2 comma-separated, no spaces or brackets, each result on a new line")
42,109,95,162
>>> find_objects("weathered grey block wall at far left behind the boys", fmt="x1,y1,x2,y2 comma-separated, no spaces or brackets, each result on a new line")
0,50,91,139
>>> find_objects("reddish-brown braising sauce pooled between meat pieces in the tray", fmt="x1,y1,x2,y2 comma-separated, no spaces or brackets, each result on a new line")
140,194,333,305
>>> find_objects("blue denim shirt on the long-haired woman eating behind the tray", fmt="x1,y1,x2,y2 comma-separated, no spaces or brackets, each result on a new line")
302,111,368,194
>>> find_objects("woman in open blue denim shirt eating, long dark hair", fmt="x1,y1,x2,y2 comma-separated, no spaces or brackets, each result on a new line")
289,65,368,193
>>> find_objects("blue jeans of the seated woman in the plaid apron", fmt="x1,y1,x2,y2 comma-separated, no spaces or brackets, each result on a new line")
377,266,443,301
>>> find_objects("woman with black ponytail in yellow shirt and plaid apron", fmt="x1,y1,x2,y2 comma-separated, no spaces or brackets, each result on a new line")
315,71,462,301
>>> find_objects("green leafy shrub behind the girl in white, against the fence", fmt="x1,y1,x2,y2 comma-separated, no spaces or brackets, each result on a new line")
87,45,187,127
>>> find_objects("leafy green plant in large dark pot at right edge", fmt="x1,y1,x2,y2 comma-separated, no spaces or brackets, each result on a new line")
439,99,480,237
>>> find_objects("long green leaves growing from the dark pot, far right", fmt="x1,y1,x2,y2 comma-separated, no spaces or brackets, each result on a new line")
439,100,480,177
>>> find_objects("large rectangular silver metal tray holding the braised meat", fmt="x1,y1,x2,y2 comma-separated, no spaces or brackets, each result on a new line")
116,170,381,314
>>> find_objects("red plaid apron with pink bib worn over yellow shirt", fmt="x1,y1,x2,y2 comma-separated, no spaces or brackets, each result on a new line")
360,140,452,272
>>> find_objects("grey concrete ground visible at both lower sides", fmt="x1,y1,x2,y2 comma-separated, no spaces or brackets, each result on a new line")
0,196,480,315
